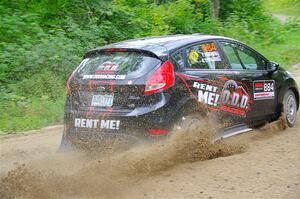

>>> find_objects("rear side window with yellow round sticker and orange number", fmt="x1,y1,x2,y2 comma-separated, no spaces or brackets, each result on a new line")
185,42,225,69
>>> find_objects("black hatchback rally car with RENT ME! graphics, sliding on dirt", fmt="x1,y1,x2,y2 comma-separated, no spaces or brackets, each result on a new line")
62,34,299,149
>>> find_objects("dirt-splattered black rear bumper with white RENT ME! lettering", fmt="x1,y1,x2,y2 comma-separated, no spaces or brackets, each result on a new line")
64,103,176,145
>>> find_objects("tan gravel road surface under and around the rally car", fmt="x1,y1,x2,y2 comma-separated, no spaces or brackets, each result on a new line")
0,66,300,199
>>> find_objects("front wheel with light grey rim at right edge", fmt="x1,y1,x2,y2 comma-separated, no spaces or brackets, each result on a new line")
283,90,297,127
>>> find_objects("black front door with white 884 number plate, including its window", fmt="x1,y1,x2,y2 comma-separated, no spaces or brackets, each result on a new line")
218,40,276,118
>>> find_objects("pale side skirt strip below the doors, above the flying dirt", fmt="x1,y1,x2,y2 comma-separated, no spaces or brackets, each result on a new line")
213,124,252,142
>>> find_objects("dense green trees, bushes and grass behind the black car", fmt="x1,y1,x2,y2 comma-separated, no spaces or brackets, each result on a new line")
0,0,300,132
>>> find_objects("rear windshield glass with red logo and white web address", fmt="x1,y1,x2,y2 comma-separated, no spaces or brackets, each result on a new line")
78,52,161,79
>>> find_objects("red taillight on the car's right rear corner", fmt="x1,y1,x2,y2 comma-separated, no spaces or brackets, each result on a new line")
144,60,174,95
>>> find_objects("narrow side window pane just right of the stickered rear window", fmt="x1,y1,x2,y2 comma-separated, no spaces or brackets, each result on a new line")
221,42,244,70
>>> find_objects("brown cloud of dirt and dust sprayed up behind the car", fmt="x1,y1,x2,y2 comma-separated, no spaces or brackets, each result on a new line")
0,116,245,199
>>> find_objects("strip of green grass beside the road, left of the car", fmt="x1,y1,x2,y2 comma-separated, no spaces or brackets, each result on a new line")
0,97,65,135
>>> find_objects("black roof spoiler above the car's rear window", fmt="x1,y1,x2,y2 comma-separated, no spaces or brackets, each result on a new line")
83,48,162,60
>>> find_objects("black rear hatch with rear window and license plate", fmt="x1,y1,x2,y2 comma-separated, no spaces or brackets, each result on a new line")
69,49,162,114
